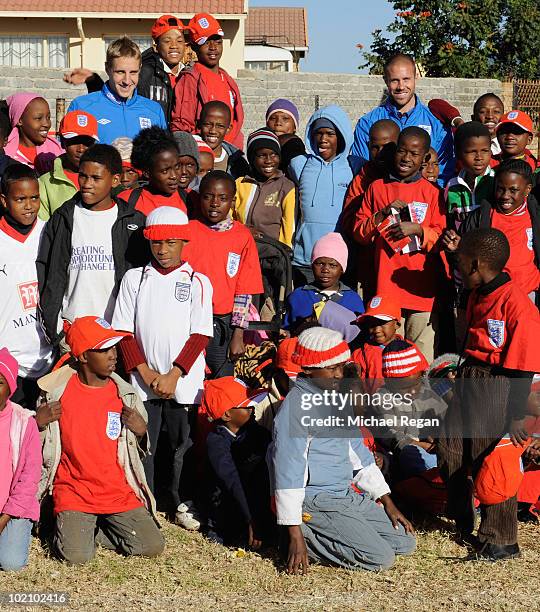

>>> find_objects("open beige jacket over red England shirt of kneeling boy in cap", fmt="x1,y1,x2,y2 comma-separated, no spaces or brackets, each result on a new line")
38,366,159,524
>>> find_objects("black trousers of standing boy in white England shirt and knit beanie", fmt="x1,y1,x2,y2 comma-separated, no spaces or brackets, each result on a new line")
143,399,195,511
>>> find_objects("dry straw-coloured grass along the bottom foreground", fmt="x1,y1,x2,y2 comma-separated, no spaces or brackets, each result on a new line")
0,525,540,612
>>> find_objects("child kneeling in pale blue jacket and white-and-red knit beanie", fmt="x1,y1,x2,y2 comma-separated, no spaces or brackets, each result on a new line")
271,327,416,574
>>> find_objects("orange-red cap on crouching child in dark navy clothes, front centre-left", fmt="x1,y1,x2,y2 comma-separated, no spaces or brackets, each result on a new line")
201,376,265,421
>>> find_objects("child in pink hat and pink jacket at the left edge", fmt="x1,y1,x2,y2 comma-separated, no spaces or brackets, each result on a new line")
0,348,41,571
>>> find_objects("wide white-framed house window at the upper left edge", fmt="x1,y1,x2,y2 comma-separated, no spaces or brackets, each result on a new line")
0,35,69,68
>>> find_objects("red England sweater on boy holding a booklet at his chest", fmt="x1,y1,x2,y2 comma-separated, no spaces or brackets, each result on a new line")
354,178,446,312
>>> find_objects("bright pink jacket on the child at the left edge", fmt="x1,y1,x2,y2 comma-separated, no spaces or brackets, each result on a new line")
2,400,42,521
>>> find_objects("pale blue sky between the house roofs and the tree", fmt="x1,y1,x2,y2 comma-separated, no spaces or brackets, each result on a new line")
249,0,394,74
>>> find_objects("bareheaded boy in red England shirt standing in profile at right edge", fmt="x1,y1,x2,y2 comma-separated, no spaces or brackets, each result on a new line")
438,228,540,561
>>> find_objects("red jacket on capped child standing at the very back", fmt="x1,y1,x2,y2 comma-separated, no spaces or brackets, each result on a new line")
171,62,244,149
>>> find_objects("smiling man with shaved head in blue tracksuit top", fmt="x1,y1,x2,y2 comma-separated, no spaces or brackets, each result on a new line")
350,54,455,186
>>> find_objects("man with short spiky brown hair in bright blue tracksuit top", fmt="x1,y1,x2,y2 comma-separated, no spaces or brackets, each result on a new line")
68,37,167,144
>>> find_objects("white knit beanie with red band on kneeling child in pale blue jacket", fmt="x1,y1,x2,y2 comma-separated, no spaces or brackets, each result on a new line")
292,327,351,368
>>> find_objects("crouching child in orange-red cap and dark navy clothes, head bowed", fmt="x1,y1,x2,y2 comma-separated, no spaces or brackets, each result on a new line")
201,376,275,549
